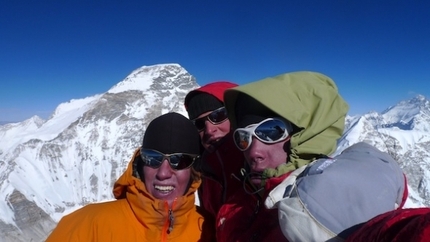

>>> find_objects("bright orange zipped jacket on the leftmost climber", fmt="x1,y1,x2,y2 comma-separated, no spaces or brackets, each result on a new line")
46,149,214,242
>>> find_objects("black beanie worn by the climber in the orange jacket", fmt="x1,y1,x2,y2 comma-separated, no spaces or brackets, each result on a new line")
142,113,200,155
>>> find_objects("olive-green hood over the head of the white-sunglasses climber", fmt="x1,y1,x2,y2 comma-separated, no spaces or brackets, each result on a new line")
224,71,348,177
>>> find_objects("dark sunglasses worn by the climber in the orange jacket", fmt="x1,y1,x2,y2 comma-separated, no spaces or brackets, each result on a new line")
140,148,199,170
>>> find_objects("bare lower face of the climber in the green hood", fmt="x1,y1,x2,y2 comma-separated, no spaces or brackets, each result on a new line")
243,137,289,187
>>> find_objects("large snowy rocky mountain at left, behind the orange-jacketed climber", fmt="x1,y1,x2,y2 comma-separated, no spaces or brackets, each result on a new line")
0,64,198,241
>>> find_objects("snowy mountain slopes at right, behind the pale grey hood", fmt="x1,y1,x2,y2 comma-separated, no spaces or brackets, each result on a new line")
336,95,430,206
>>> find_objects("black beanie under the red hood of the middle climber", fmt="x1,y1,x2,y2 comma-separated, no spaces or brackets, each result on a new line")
187,92,224,119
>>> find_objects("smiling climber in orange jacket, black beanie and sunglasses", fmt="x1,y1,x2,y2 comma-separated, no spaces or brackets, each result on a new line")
47,113,214,242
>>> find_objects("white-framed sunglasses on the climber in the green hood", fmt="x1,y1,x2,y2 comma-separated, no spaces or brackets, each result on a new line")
233,118,292,151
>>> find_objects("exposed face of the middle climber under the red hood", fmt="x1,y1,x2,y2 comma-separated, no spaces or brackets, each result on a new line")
197,111,230,151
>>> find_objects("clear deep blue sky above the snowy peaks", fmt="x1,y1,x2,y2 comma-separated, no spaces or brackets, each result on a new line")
0,0,430,121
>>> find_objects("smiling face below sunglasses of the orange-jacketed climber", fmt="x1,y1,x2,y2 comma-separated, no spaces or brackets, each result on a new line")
143,159,191,206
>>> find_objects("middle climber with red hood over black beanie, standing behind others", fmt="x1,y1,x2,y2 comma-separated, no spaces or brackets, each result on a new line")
185,81,244,222
